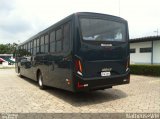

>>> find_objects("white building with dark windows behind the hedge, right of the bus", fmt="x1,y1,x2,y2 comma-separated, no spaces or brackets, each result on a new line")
130,36,160,64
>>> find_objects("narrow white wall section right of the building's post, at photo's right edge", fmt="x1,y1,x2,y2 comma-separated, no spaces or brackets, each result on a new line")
153,40,160,64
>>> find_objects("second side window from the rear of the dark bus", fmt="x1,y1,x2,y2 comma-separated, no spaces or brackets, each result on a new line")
56,28,63,52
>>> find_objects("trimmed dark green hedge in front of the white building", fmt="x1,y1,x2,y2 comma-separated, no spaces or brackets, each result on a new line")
130,65,160,76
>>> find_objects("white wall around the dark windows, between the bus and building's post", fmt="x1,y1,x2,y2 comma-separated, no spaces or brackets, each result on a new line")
130,41,152,64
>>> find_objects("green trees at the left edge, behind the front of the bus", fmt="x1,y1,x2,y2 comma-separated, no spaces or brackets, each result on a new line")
0,43,17,54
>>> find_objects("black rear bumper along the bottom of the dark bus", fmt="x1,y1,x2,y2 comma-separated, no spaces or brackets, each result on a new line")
74,71,130,92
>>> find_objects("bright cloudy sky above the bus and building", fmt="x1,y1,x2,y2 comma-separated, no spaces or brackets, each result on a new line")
0,0,160,44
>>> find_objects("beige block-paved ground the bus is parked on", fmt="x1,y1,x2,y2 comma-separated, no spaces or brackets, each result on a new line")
0,69,160,113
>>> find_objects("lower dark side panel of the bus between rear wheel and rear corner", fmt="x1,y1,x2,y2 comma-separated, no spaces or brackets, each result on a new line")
40,53,72,91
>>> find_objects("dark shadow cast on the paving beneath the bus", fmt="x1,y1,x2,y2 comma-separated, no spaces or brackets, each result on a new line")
19,77,128,107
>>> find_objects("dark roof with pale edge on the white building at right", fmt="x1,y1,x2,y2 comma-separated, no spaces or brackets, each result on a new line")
129,36,160,43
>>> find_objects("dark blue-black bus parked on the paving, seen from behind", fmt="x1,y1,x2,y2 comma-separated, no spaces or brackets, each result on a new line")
15,12,130,92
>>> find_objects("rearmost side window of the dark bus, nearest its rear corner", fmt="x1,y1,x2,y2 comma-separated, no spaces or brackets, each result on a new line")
63,22,70,52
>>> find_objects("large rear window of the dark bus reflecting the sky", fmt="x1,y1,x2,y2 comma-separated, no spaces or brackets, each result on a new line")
80,18,126,41
